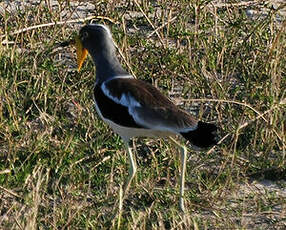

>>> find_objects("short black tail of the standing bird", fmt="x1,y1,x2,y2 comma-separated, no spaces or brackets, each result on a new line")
181,121,217,148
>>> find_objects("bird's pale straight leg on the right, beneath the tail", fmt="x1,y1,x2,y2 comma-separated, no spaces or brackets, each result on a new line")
169,137,187,212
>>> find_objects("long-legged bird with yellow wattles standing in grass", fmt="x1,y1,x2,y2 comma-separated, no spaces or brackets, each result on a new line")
66,23,217,211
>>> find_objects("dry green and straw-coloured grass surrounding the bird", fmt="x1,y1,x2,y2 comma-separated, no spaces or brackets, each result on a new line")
0,1,286,229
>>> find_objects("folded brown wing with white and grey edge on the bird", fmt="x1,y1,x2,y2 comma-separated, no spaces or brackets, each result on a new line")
102,78,197,133
